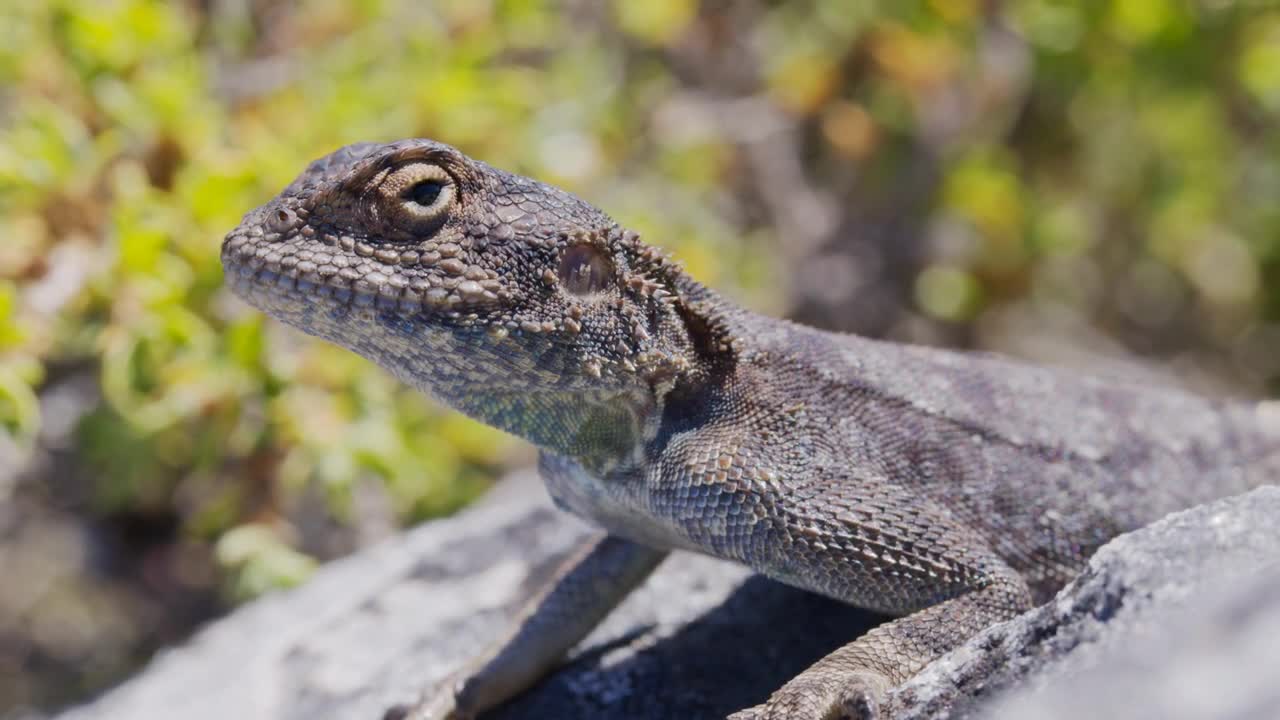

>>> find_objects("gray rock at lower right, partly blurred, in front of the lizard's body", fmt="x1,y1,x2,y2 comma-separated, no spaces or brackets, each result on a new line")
899,487,1280,720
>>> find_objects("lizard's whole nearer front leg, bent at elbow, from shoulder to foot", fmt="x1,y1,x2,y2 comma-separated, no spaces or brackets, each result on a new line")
648,427,1032,720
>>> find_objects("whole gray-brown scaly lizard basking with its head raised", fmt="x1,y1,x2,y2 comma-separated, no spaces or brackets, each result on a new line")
221,140,1280,720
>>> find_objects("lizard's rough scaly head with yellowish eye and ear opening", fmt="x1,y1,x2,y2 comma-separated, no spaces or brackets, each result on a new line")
221,140,708,453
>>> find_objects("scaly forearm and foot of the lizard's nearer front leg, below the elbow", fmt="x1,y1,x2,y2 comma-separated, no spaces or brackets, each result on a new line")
730,570,1030,720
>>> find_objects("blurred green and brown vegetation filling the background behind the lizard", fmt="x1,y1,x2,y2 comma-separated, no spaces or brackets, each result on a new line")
0,0,1280,719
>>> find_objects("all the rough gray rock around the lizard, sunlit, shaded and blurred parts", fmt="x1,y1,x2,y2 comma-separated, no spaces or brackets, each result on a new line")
63,478,1280,720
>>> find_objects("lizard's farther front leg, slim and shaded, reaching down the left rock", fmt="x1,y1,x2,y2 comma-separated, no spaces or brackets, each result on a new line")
387,534,667,720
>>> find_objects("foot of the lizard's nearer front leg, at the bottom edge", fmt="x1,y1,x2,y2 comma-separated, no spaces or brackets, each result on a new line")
728,671,890,720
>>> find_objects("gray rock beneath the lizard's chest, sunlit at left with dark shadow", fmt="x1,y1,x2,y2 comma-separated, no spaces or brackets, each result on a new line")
61,478,881,720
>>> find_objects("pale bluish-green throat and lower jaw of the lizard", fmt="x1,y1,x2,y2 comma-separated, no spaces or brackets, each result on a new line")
225,248,660,474
